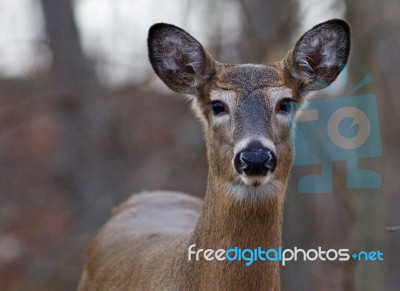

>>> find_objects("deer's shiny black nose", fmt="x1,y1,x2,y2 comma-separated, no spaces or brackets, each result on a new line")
234,142,277,176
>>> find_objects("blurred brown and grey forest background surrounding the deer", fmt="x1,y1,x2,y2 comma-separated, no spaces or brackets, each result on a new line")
0,0,400,290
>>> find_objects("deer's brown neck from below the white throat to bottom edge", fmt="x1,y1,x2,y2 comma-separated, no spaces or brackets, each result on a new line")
186,178,284,290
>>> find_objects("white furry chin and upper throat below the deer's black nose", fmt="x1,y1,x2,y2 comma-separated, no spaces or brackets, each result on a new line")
225,173,285,202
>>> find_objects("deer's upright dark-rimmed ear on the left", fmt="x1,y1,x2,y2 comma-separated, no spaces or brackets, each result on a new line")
147,23,214,94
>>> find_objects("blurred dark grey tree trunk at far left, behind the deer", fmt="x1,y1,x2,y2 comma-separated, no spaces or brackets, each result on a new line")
42,0,109,210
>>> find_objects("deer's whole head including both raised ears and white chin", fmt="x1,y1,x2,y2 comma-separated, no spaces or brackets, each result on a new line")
148,20,350,199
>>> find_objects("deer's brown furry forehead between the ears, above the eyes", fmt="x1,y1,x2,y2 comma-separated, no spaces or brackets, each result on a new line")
214,64,284,94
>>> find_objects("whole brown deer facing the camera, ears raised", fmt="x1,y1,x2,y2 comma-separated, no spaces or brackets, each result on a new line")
78,19,350,291
